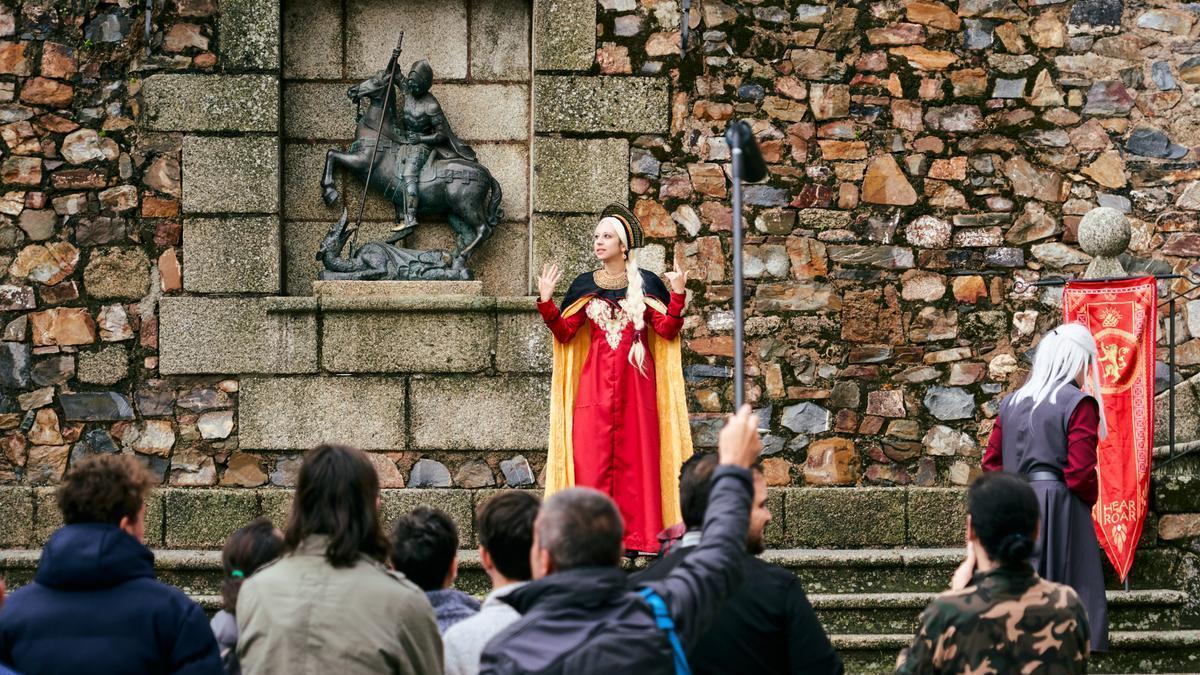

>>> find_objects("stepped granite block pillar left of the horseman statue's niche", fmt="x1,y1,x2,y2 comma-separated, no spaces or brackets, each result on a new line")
140,0,282,294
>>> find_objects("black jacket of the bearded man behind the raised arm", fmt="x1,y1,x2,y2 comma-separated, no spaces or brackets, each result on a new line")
634,546,842,675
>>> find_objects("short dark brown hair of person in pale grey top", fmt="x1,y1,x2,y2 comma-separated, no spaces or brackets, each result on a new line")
475,490,541,581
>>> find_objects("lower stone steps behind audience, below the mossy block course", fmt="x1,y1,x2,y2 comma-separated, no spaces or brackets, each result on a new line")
0,540,1200,673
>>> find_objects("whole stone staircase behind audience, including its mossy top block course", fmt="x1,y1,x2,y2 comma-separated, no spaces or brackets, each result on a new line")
0,454,1200,674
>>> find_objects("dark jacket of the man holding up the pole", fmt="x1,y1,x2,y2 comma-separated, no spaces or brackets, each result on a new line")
480,466,754,675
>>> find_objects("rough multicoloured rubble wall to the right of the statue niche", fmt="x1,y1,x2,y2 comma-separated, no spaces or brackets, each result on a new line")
566,0,1200,485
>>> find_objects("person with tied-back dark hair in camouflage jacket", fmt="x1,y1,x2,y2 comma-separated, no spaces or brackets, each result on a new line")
896,473,1088,674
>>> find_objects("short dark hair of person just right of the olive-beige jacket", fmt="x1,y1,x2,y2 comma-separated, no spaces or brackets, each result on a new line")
391,506,458,591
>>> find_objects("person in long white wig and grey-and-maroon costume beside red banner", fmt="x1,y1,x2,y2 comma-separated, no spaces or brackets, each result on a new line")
983,323,1109,652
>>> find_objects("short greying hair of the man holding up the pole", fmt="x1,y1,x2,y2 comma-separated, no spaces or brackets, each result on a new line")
536,488,625,572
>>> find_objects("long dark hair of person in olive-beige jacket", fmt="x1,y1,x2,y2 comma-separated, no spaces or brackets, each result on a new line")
283,444,388,567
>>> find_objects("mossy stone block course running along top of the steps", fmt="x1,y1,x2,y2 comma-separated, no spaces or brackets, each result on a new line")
0,480,1200,554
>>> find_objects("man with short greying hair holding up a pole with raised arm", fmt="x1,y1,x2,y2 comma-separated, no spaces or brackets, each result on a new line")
480,406,761,675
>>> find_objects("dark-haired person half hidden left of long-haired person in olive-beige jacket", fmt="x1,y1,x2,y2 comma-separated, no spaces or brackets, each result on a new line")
211,518,283,675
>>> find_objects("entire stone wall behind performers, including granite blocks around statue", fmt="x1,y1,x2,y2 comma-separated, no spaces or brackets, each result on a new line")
0,0,1200,557
